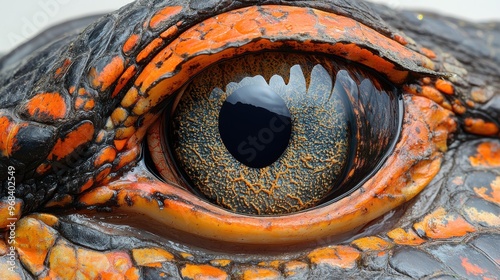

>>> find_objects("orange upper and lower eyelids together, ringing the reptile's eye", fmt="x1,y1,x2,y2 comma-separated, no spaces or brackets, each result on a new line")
80,6,456,244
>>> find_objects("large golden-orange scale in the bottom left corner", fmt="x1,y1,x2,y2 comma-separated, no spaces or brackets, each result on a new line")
16,218,57,275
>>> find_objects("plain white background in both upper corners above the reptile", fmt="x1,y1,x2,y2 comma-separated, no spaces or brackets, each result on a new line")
0,0,500,53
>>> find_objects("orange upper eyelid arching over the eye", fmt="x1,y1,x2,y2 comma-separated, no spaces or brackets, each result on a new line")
126,5,440,118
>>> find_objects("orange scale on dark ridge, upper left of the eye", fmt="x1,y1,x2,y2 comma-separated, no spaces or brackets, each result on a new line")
88,56,125,91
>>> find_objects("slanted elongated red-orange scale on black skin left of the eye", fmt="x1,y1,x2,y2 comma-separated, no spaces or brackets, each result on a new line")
47,121,94,160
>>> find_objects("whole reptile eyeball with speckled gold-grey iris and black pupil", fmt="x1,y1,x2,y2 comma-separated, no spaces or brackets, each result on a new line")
150,52,402,215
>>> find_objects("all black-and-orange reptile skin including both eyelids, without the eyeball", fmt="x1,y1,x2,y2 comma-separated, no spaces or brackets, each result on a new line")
0,0,500,279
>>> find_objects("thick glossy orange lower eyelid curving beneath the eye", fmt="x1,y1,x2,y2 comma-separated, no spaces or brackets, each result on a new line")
87,95,456,244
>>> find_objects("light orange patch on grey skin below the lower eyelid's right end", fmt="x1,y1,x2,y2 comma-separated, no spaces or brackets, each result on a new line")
413,208,476,239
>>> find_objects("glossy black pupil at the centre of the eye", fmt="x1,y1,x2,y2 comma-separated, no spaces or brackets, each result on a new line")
219,85,292,168
